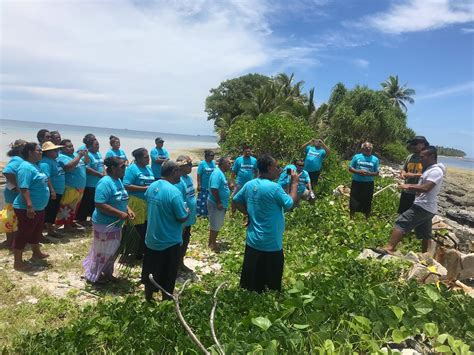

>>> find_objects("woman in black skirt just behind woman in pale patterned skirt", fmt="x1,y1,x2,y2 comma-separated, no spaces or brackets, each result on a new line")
77,137,105,225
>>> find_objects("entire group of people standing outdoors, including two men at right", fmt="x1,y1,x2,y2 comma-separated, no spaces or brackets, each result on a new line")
3,129,445,300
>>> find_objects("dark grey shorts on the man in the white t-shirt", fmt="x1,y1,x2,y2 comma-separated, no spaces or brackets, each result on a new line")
395,205,434,239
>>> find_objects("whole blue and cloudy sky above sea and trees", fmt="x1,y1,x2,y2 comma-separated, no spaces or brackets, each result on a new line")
0,0,474,157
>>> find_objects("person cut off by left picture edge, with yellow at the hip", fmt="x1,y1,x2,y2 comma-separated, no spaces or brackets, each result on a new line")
0,139,26,249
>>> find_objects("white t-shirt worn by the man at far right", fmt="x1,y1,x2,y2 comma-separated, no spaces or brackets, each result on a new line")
414,164,446,214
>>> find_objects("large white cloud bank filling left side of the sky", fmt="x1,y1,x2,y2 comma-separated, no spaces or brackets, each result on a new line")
0,0,316,133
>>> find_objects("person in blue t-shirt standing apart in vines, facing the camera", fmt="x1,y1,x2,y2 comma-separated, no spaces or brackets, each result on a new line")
349,142,380,218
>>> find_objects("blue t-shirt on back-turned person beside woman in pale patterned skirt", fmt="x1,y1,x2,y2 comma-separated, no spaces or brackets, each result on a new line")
145,180,188,250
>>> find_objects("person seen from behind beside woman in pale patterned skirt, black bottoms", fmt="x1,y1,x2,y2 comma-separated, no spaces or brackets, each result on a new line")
142,160,188,301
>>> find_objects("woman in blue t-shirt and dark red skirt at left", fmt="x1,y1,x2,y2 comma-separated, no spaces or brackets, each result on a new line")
13,142,49,270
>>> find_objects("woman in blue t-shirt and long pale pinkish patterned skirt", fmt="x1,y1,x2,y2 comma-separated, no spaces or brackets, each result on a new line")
82,157,135,283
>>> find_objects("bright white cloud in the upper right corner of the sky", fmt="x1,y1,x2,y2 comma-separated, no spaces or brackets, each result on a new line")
360,0,474,34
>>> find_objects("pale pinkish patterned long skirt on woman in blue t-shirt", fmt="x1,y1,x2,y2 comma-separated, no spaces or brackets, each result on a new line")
82,223,122,282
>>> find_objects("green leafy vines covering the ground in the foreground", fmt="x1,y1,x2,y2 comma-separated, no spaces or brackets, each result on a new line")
5,164,474,354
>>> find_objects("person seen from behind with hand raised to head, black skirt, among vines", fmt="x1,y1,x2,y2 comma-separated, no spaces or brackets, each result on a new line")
233,155,298,292
